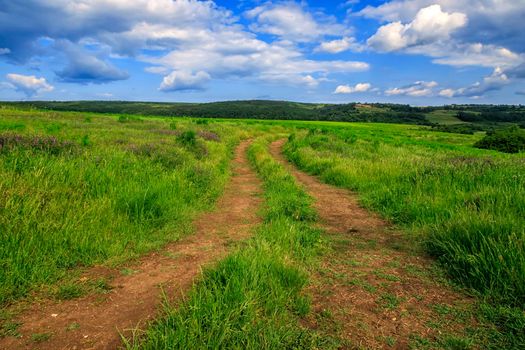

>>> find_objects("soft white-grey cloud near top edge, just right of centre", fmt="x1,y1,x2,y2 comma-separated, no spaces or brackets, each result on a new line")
245,2,345,42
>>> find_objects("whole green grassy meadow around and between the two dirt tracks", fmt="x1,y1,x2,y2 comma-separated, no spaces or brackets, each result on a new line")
0,105,525,349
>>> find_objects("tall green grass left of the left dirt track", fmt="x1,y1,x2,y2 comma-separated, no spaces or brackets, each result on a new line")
0,109,243,304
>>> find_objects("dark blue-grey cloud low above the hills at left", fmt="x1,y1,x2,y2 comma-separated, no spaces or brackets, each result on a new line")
56,41,129,84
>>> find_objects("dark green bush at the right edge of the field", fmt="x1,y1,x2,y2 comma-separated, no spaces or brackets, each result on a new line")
474,126,525,153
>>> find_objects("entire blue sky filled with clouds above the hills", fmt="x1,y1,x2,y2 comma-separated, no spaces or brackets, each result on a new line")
0,0,525,105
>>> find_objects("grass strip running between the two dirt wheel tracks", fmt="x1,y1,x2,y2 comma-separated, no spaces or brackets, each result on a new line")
128,139,331,349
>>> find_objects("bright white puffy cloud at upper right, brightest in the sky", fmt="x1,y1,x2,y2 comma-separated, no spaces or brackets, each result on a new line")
367,5,467,52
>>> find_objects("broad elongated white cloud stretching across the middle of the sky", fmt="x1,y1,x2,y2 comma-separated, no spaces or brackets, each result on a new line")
145,32,369,87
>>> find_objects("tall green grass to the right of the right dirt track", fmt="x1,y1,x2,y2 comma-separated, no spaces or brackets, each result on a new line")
285,124,525,308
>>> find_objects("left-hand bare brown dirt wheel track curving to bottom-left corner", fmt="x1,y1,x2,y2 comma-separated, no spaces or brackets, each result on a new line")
0,141,260,350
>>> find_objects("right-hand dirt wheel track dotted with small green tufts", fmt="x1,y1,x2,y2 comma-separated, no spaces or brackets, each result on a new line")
270,140,475,349
